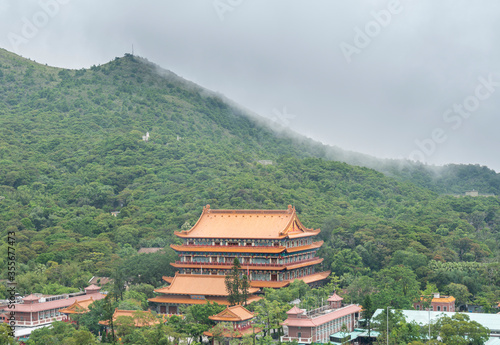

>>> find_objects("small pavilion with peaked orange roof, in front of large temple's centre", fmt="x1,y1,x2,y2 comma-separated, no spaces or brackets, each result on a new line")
203,305,261,341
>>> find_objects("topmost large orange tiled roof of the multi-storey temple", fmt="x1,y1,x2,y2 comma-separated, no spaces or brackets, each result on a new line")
175,205,320,239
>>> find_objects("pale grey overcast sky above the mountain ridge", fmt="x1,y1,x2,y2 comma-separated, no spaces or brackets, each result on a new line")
0,0,500,172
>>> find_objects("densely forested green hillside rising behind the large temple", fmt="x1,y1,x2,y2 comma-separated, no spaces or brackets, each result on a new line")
0,50,500,310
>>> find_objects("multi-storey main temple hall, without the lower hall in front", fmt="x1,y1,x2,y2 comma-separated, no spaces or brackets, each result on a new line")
171,205,330,288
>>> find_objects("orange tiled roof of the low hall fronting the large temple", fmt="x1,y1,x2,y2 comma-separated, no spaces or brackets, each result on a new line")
155,273,259,297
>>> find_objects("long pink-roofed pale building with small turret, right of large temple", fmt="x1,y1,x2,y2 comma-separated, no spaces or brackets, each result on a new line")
281,293,362,344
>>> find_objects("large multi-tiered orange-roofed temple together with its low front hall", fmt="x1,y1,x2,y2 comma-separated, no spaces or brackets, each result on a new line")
149,205,330,314
